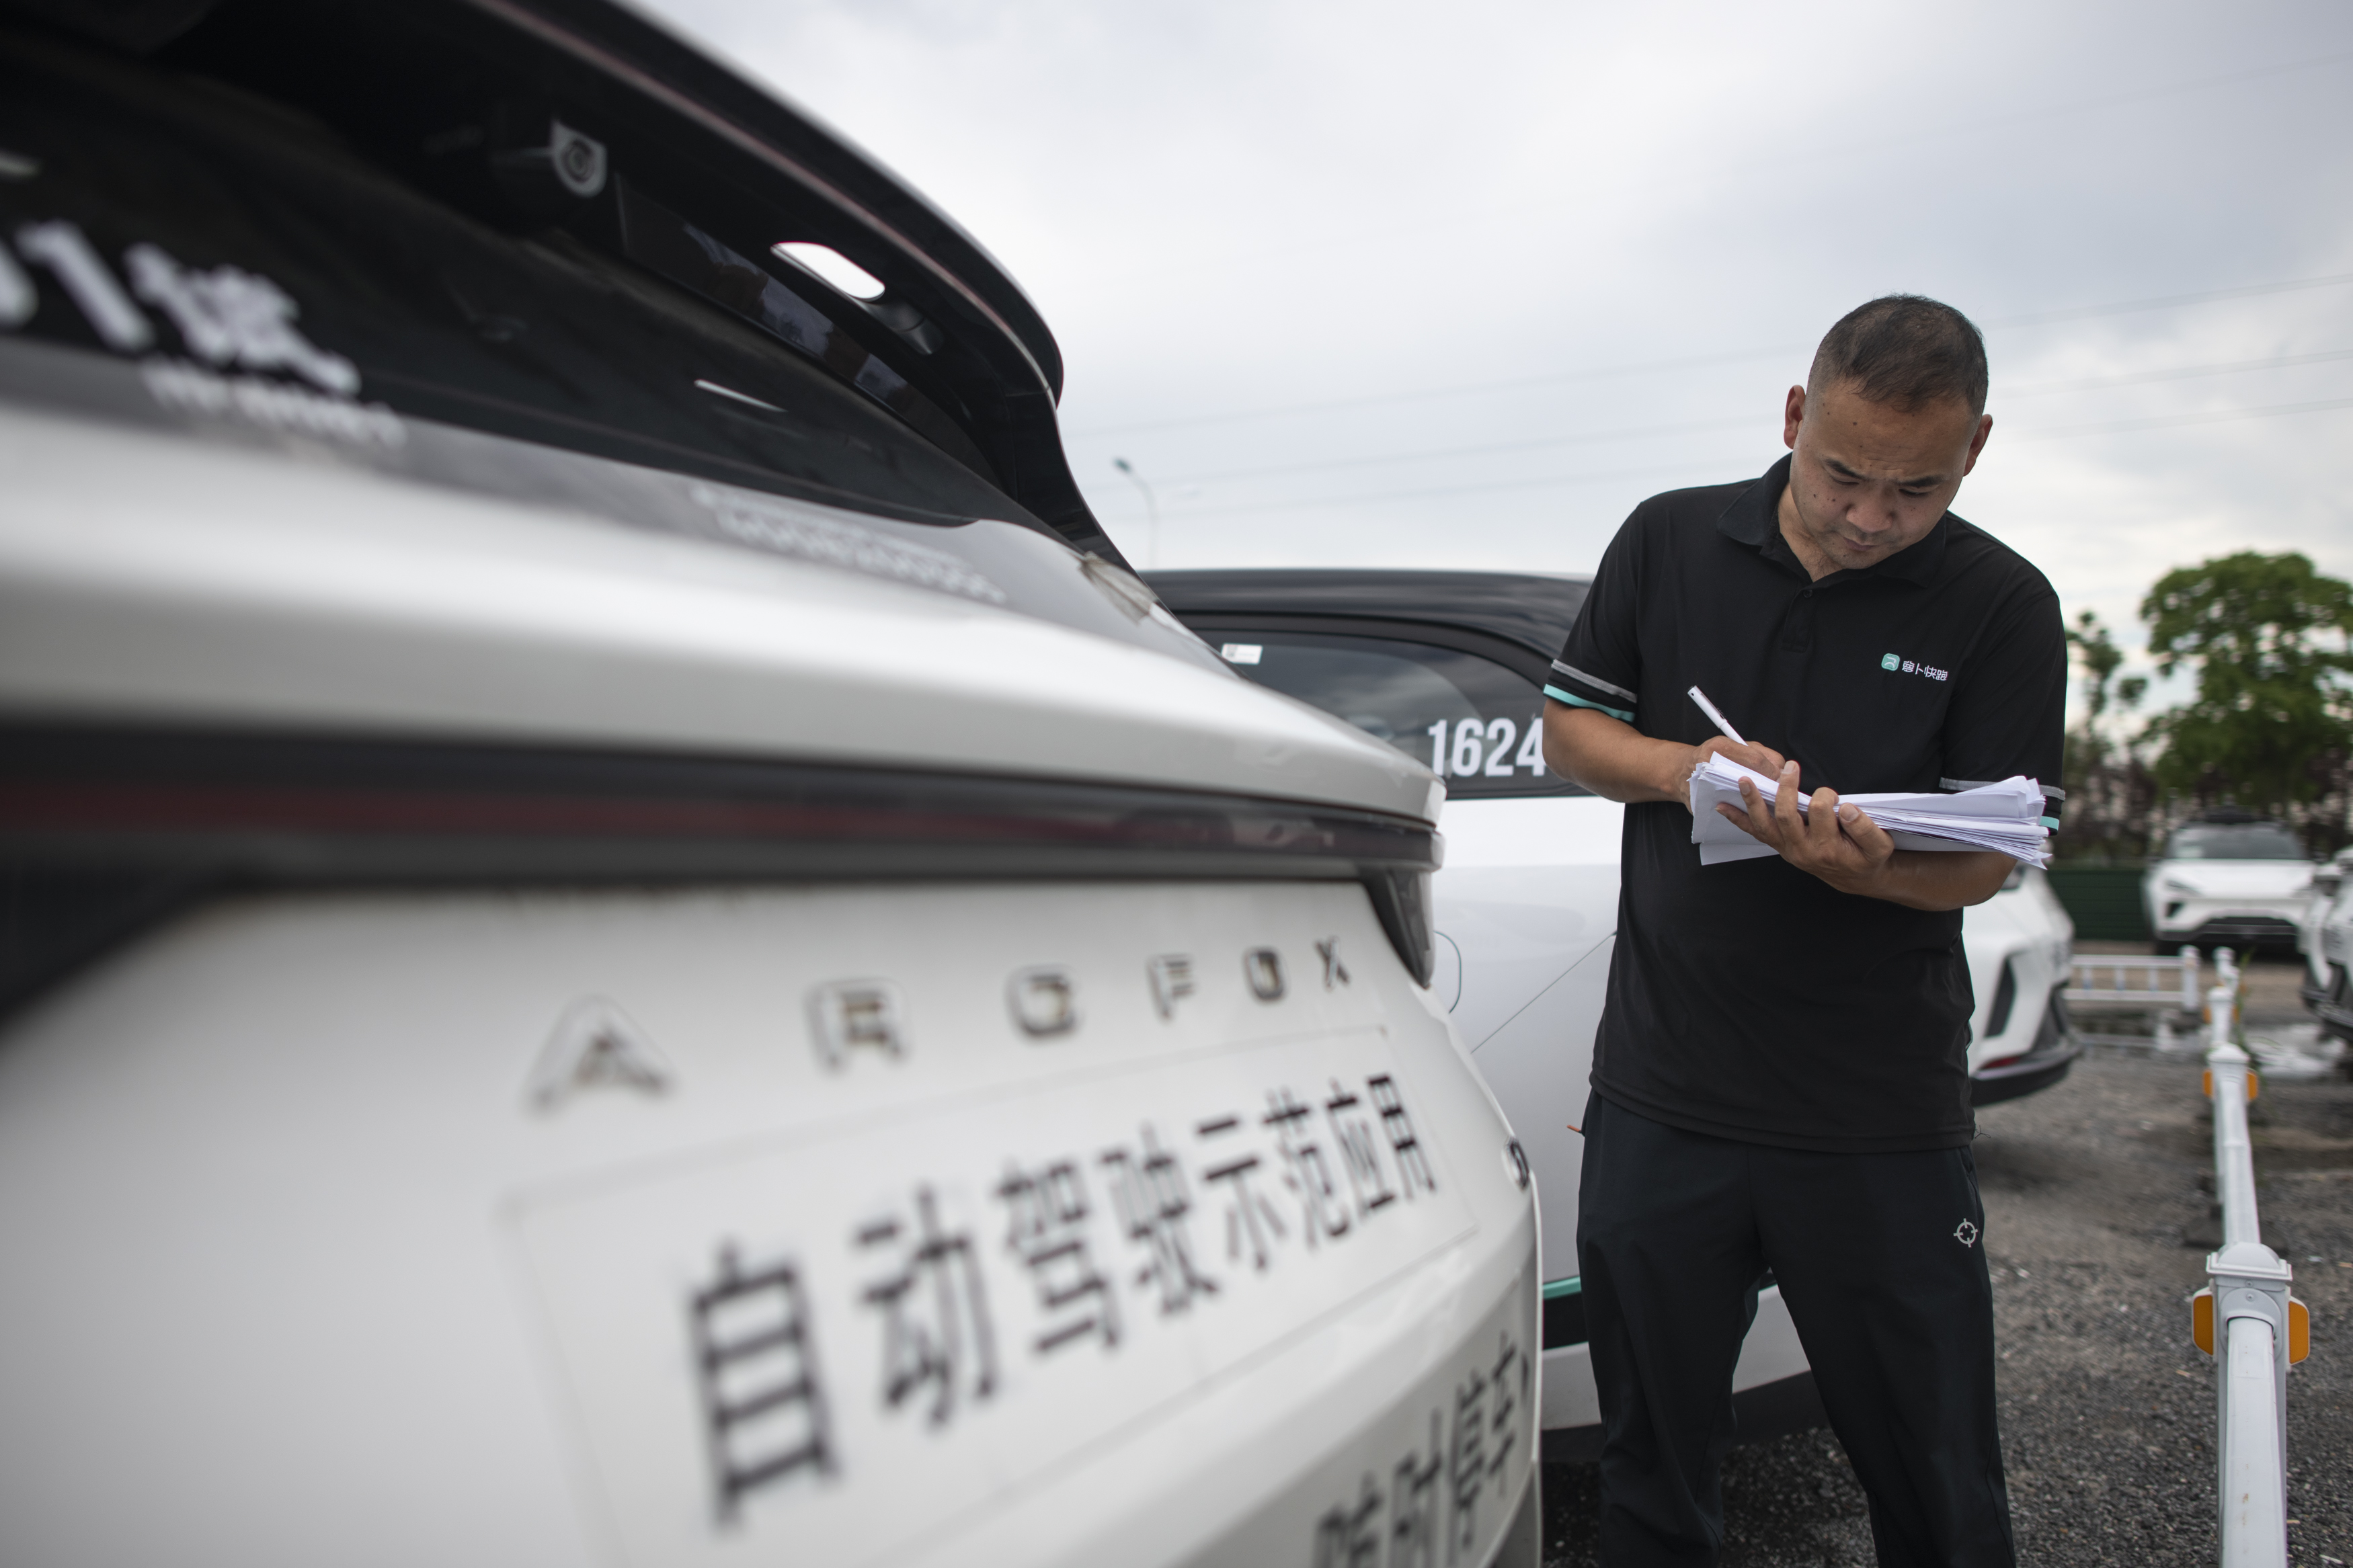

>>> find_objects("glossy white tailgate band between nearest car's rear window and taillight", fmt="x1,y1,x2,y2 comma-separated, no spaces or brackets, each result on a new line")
0,414,1440,821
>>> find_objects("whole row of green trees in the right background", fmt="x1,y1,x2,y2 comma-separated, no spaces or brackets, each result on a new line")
2059,550,2353,860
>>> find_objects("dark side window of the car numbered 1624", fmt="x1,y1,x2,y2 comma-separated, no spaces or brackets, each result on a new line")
1212,630,1581,799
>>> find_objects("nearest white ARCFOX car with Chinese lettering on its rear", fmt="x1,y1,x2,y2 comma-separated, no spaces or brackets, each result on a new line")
0,12,1542,1568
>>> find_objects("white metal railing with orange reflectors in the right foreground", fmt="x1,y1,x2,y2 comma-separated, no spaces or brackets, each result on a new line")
2191,948,2311,1568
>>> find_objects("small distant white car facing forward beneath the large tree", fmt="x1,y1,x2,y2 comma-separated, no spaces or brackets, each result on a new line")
2141,807,2313,952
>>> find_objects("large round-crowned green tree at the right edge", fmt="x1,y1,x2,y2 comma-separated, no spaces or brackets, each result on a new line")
2141,550,2353,818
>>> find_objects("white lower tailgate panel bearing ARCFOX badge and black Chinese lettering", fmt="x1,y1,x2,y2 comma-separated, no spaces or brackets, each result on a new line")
0,886,1537,1563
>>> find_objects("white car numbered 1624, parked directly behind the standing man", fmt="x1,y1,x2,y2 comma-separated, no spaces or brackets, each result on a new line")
1151,569,2080,1460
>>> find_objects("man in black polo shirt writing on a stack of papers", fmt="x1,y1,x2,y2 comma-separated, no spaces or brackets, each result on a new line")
1544,296,2066,1568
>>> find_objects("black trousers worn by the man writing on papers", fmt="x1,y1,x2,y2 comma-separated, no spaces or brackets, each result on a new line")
1577,1093,2017,1568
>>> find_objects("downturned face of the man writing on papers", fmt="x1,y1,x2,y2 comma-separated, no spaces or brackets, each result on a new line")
1782,381,1993,576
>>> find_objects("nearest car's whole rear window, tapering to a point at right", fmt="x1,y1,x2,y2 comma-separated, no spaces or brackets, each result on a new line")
0,26,1242,665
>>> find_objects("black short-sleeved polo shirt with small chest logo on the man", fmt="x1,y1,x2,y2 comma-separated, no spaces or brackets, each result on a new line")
1546,456,2066,1152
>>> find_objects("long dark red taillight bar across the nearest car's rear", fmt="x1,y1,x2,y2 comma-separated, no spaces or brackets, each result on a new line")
0,727,1438,1009
